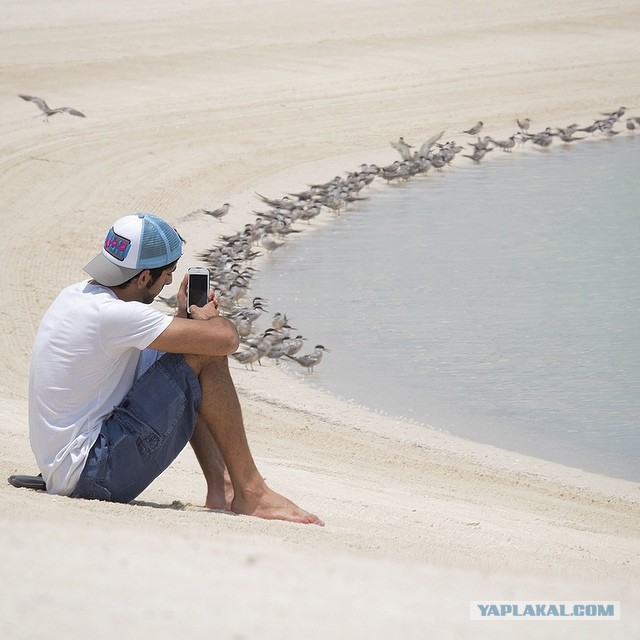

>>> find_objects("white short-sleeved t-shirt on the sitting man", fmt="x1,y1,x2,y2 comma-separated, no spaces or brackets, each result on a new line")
29,281,172,495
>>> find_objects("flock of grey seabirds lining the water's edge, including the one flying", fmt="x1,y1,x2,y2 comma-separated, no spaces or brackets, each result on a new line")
19,94,640,372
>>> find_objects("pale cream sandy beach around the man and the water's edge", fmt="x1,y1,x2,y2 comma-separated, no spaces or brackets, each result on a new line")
0,0,640,640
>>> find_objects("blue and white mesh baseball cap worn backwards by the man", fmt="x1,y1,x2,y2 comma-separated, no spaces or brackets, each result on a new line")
84,213,183,287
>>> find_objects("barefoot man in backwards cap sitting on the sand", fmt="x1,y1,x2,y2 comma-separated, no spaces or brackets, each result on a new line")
29,213,323,525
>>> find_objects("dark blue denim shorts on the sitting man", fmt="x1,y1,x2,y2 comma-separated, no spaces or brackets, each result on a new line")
72,352,202,503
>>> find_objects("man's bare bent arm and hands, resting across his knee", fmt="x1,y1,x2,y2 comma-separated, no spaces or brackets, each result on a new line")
149,276,240,356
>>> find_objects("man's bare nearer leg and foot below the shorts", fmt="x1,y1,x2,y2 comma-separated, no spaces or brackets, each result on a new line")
185,355,324,525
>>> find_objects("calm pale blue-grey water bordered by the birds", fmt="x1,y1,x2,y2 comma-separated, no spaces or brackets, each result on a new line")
254,134,640,480
